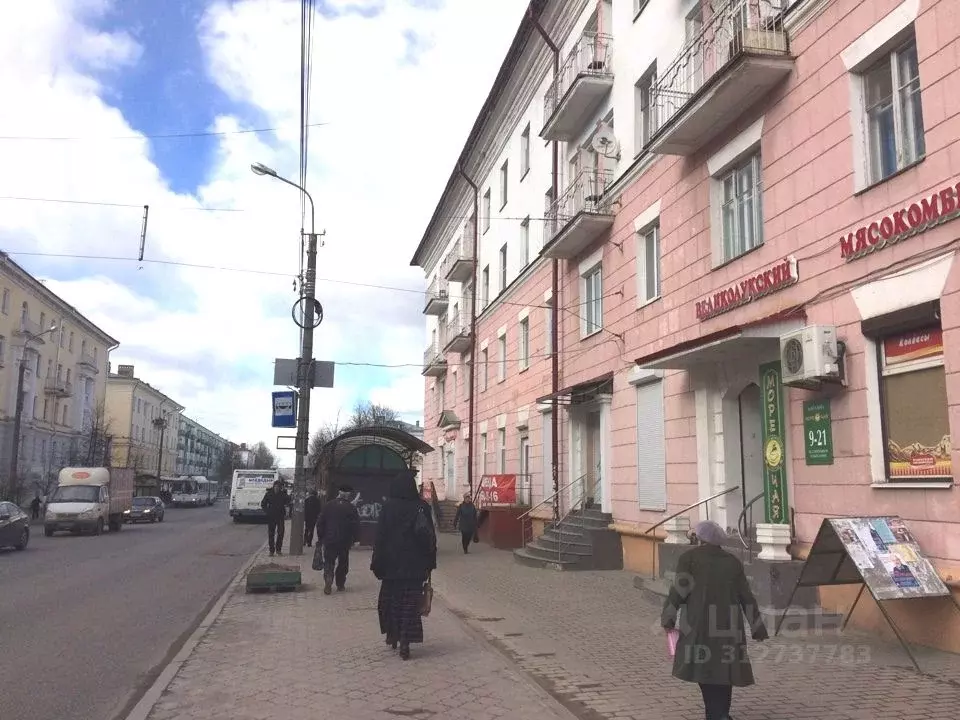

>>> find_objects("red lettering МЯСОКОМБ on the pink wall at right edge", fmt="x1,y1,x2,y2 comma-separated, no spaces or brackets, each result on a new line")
840,184,960,261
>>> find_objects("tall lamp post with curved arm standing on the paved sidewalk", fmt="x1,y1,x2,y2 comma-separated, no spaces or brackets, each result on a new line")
250,163,317,555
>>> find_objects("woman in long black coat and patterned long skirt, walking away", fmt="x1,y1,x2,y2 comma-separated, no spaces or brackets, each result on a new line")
370,477,437,660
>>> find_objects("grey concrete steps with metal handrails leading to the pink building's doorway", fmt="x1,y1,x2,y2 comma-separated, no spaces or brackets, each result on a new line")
513,509,623,570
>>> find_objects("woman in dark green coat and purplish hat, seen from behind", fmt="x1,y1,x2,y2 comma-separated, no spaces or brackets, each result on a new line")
661,521,768,720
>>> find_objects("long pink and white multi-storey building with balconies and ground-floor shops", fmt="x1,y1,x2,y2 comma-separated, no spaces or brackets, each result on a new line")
412,0,960,648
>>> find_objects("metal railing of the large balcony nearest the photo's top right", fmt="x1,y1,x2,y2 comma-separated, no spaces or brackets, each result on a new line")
651,0,790,134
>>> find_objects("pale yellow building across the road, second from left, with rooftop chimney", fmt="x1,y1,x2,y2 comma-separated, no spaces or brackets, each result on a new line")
106,365,184,492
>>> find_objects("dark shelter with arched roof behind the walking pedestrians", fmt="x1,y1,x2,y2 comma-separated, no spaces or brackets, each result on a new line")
314,425,433,546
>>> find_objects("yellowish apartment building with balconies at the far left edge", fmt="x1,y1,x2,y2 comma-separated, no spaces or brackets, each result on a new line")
0,253,118,500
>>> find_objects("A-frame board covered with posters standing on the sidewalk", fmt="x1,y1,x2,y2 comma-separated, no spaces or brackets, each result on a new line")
797,516,950,601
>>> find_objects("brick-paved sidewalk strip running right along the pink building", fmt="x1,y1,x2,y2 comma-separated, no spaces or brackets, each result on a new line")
434,537,960,720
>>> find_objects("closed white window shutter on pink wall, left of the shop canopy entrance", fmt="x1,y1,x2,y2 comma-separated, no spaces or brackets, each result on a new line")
637,377,667,511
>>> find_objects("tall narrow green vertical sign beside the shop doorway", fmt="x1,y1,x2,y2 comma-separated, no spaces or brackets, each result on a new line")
760,360,790,525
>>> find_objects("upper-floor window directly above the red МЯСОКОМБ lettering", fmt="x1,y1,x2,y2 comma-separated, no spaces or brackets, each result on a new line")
863,38,926,183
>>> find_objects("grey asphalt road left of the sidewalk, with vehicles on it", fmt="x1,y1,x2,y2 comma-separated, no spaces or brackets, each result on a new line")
0,501,267,720
